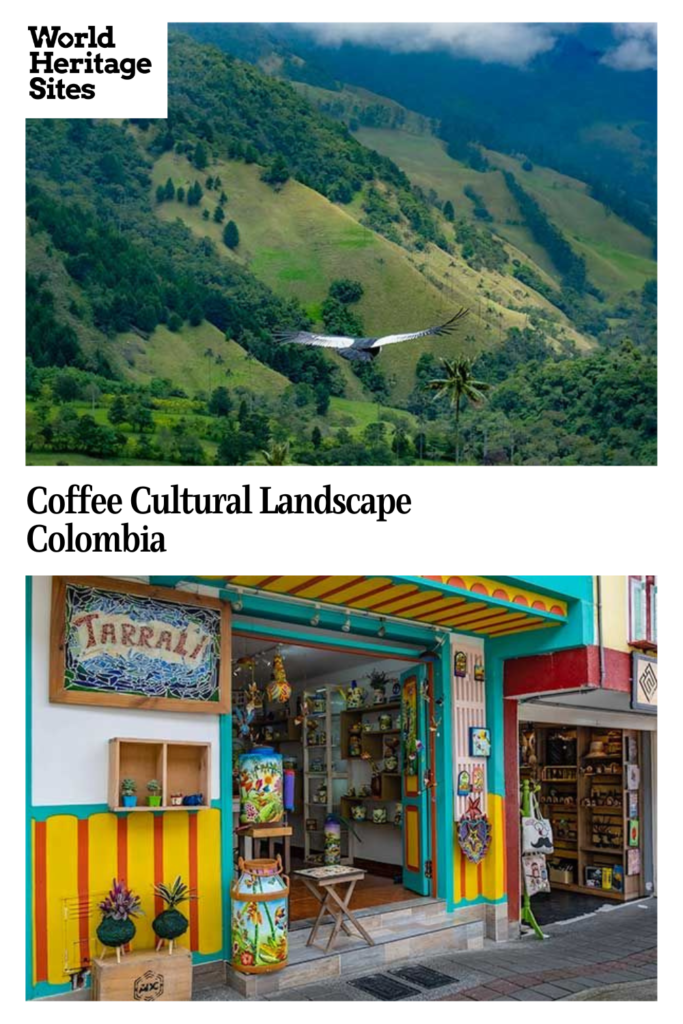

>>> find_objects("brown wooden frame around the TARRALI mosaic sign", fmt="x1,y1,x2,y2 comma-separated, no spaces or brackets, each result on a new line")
50,575,232,715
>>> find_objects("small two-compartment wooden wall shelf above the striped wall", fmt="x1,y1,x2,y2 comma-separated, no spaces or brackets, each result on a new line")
108,737,211,814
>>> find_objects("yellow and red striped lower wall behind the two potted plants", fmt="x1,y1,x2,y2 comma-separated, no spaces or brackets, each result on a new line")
31,808,223,986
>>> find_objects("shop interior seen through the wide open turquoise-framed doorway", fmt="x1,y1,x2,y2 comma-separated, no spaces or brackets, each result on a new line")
232,629,430,923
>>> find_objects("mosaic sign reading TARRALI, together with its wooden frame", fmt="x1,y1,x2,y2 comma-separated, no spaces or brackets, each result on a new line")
50,577,230,714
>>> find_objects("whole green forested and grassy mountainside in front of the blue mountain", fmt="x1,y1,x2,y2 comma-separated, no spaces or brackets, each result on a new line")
27,27,656,465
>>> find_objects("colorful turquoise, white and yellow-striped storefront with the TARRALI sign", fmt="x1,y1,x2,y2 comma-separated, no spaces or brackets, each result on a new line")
27,575,596,998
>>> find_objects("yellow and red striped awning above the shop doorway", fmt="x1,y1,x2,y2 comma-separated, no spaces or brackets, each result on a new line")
195,575,567,637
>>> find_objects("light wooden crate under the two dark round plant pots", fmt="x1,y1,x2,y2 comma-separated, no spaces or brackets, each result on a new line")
92,946,193,1002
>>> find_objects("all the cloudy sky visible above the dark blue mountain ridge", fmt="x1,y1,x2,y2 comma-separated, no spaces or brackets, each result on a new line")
298,23,656,71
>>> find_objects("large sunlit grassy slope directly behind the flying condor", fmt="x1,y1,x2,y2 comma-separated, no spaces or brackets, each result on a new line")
152,148,588,399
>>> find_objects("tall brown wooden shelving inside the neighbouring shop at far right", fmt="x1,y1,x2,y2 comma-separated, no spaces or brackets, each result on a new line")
521,724,643,900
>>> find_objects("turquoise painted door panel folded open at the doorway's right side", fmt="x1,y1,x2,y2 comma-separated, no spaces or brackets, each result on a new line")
400,665,430,896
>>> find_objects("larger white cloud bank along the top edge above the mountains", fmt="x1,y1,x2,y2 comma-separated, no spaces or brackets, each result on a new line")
298,23,571,66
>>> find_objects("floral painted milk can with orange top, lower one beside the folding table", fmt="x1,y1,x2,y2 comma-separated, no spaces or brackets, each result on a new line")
230,857,290,974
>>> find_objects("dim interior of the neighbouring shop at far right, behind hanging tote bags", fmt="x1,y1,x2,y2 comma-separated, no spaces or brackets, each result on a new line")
519,722,642,925
